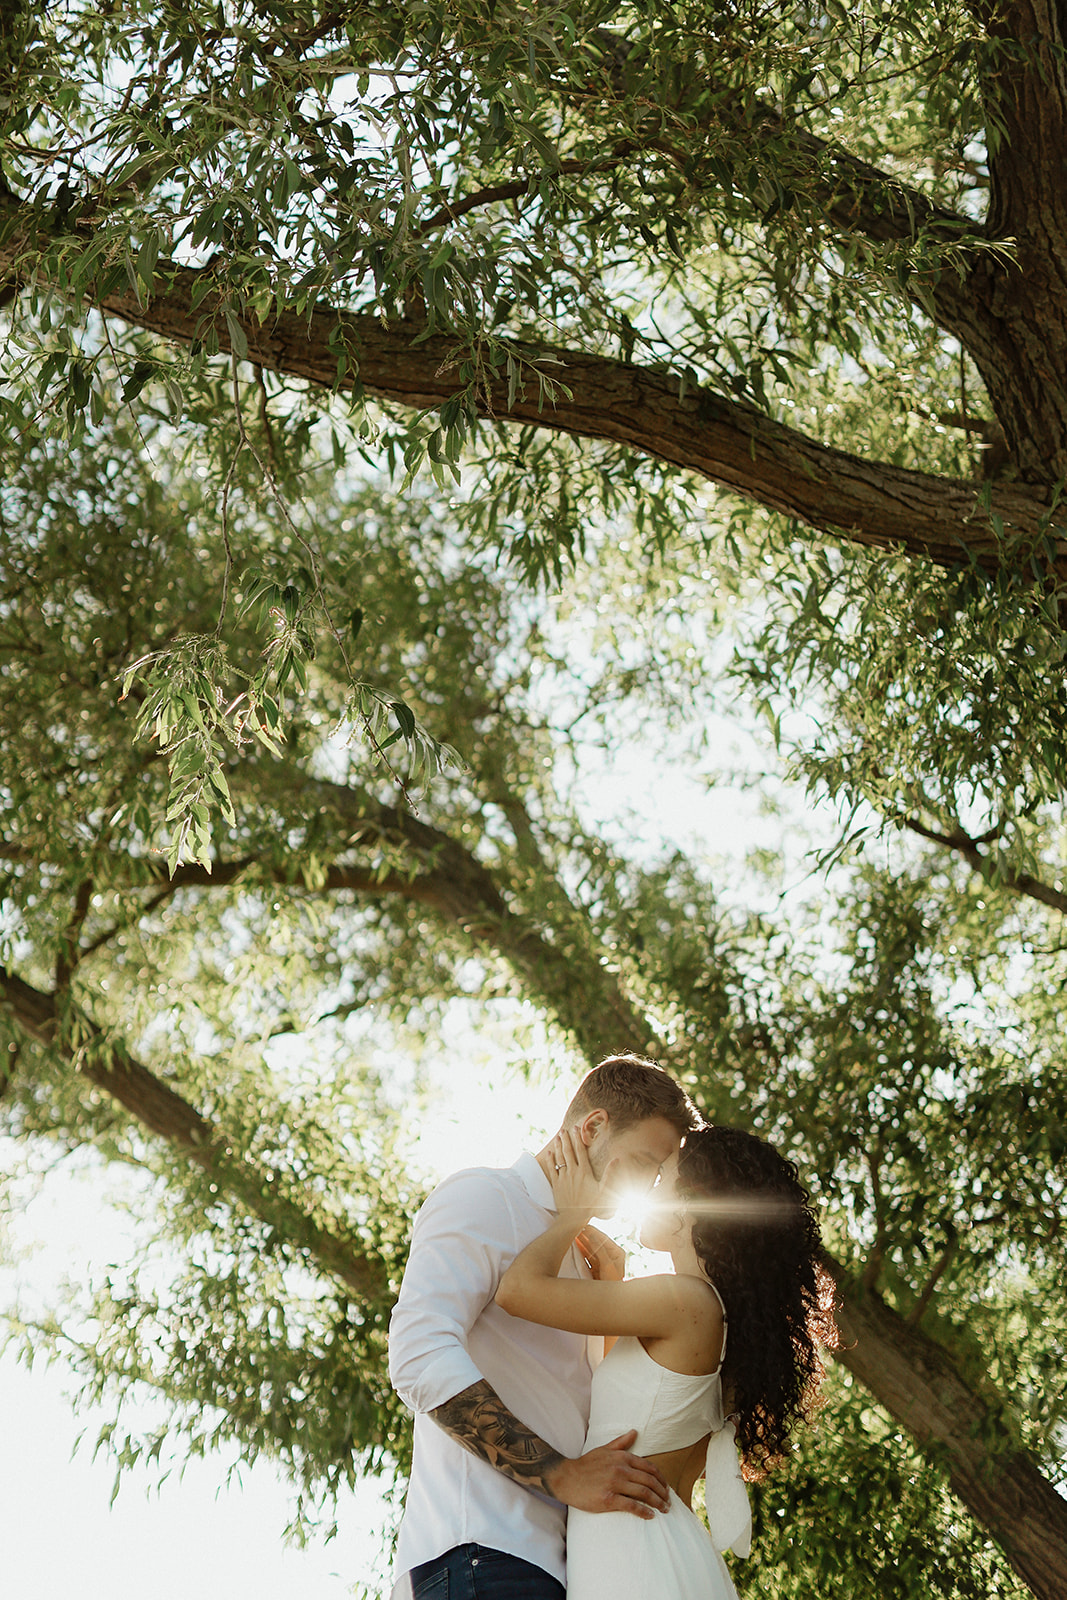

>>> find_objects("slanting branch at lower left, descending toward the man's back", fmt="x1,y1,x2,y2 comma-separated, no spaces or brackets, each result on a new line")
0,968,389,1302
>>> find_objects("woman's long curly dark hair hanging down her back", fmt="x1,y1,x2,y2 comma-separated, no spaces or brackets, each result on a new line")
678,1126,838,1478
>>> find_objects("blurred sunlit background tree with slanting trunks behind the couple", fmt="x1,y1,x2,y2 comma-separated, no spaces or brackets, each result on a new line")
0,419,1067,1595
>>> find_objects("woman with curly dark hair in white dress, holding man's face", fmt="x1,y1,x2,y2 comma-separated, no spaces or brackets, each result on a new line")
496,1128,837,1600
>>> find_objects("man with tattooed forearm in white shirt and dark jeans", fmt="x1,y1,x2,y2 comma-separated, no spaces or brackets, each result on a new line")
389,1056,699,1600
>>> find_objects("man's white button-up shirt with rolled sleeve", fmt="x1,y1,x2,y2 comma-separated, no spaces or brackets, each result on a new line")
389,1155,603,1595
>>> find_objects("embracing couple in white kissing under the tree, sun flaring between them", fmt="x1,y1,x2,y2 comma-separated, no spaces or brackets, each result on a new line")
389,1056,833,1600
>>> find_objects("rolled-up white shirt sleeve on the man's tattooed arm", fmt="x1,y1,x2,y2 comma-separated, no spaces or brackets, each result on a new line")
389,1170,515,1414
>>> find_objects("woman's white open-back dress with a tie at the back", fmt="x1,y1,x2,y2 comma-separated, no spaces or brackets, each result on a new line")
566,1312,752,1600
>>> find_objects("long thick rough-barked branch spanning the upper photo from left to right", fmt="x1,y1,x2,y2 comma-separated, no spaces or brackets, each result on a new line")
0,203,1046,571
